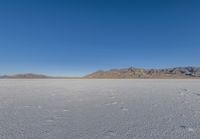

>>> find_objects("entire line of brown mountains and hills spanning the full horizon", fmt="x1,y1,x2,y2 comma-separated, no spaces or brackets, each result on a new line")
0,67,200,79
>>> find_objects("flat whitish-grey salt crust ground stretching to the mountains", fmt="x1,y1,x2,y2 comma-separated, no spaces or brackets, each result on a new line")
0,79,200,139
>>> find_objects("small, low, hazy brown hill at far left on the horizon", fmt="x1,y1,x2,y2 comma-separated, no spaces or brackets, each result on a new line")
0,73,51,79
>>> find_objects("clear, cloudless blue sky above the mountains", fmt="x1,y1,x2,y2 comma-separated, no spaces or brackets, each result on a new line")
0,0,200,76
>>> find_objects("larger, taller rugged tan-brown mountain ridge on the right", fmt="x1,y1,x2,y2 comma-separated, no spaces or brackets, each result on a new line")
84,67,200,79
